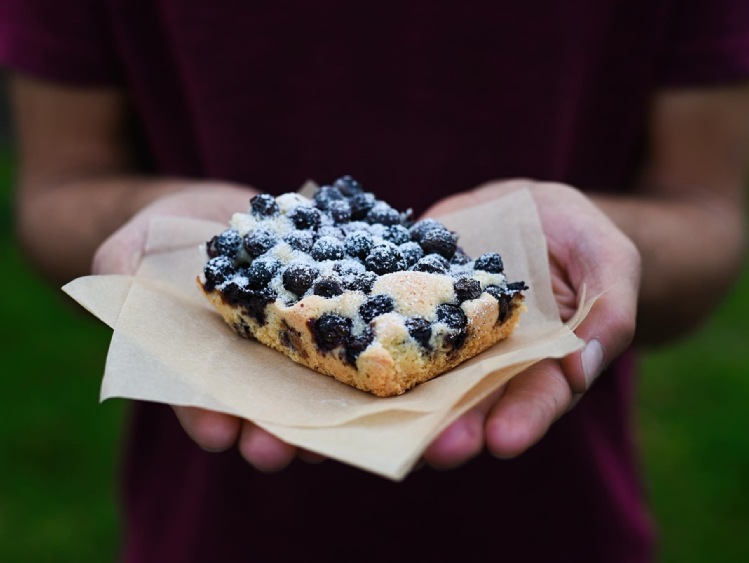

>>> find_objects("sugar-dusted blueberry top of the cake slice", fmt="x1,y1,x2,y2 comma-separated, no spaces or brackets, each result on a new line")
204,176,527,356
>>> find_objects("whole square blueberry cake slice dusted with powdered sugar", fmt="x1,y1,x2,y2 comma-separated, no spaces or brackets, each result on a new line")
198,176,527,397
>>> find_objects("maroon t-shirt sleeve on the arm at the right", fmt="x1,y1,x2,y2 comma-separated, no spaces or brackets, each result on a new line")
659,0,749,87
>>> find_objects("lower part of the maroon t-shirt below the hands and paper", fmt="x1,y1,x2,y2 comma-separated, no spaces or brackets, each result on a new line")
121,354,652,563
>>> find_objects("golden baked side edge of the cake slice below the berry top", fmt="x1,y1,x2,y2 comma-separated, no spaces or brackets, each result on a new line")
197,278,525,397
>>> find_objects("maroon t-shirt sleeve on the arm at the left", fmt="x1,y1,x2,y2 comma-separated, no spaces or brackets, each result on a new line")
0,0,119,85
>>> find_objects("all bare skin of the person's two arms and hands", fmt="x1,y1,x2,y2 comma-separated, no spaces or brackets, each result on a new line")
12,76,749,471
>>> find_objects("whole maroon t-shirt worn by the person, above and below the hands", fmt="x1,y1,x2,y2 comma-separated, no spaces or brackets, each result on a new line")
0,0,749,563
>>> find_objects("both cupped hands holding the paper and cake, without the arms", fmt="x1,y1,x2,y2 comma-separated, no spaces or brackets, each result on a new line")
93,178,639,471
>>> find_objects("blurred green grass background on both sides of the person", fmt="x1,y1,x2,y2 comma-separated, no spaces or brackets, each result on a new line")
0,76,749,563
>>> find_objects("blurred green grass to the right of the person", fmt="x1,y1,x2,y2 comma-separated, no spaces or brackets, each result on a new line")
639,266,749,563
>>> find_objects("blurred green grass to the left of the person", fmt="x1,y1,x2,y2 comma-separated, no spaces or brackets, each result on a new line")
0,150,122,562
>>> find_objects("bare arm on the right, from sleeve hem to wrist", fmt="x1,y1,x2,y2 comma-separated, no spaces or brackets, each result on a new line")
596,84,749,344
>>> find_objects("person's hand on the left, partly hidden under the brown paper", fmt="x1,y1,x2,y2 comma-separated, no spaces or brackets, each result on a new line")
92,184,322,471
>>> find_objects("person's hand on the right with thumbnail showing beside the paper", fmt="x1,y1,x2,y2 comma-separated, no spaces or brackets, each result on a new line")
424,180,641,468
